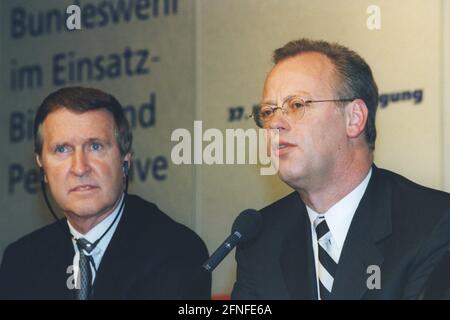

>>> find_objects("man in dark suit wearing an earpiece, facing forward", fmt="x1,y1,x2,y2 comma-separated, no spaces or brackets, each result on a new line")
0,87,211,300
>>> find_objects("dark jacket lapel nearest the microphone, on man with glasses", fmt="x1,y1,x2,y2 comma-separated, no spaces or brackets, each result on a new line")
280,193,317,300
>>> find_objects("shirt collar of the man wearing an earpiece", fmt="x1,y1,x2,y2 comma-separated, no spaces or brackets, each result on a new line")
67,193,125,251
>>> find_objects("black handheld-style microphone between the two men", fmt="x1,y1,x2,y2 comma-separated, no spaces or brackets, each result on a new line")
202,209,261,272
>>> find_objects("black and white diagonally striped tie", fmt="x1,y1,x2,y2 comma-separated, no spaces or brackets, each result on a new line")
314,217,337,300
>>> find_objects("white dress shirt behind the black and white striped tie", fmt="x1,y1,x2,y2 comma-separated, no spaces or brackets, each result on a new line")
306,168,372,297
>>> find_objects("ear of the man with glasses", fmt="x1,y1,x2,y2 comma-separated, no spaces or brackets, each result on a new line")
345,99,369,138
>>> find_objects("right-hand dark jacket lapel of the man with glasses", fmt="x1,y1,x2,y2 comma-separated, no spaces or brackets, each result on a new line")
332,165,392,299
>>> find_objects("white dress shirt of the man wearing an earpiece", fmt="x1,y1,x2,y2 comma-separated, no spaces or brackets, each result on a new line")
67,194,125,283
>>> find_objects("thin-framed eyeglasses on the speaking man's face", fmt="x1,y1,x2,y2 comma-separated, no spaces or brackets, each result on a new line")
250,96,356,128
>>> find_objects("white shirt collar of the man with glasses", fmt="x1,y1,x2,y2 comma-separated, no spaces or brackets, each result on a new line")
306,168,372,251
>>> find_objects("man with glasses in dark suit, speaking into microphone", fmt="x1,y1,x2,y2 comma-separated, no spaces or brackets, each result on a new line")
232,39,450,300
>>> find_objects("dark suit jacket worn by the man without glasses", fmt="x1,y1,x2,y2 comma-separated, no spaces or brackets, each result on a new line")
0,195,211,299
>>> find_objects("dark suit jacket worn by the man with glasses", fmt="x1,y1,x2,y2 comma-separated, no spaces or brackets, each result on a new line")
232,166,450,299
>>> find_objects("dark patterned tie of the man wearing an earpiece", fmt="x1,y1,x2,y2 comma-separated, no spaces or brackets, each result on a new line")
75,238,93,300
